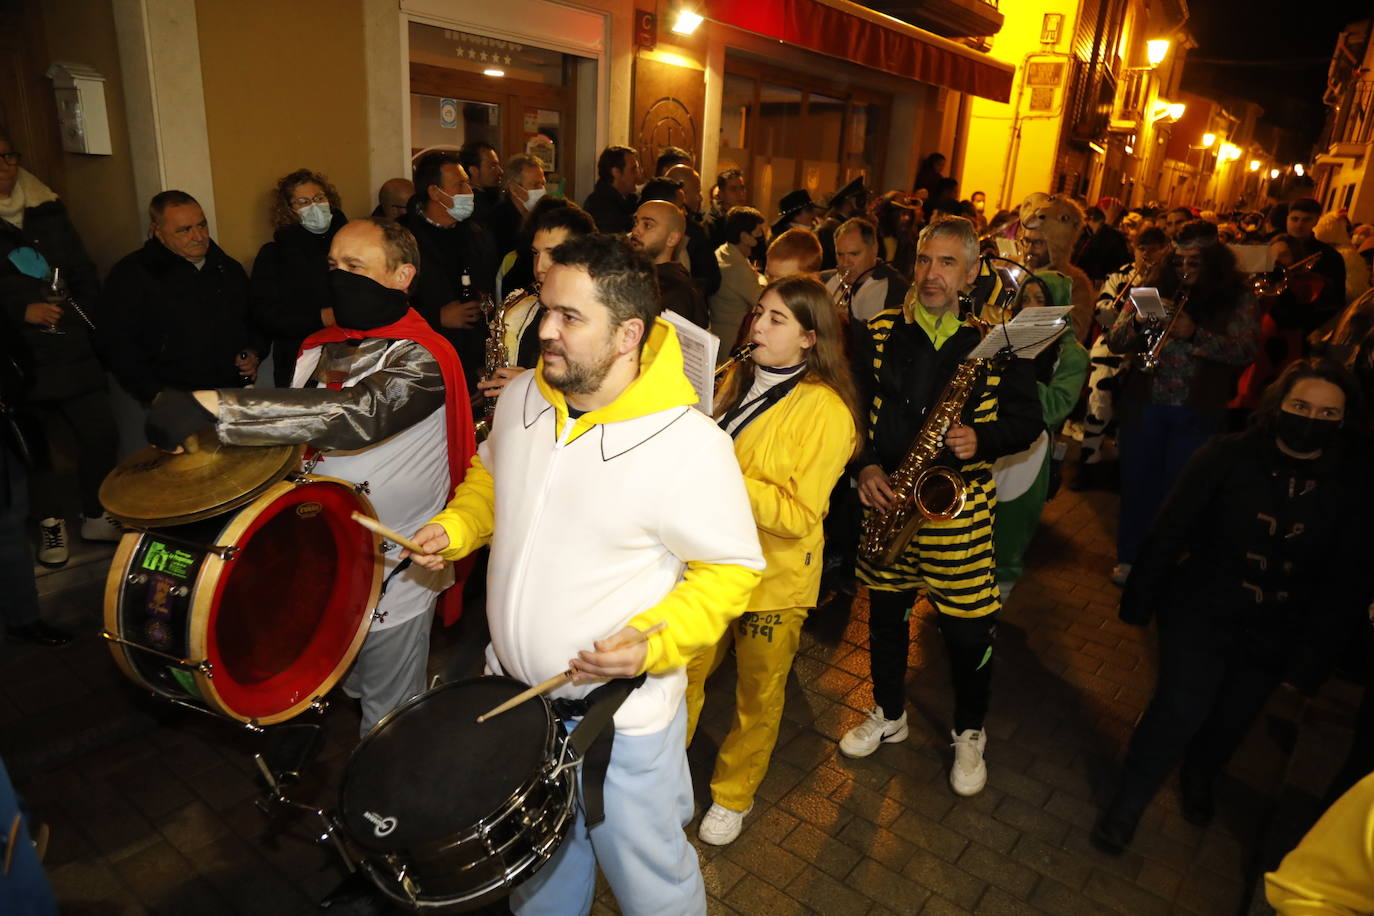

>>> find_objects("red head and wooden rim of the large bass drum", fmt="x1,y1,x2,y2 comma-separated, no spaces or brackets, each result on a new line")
191,481,382,724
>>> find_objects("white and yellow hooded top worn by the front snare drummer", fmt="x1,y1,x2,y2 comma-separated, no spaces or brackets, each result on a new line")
434,319,764,735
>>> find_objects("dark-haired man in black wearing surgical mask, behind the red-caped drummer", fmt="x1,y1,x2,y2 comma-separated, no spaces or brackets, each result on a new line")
397,151,497,393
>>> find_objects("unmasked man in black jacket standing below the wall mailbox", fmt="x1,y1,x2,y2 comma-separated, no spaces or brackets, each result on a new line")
100,191,268,407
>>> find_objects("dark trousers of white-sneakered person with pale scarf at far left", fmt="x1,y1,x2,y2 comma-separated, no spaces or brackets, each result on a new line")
29,389,120,519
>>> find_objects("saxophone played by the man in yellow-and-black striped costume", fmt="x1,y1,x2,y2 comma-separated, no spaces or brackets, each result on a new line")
859,258,1031,567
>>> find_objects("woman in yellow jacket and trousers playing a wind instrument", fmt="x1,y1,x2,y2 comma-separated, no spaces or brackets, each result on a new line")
687,276,863,846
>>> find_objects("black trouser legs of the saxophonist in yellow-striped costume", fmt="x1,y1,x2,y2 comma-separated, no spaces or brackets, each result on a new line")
868,589,998,732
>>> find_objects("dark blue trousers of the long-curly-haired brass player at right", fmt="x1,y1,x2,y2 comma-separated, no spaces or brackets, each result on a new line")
1117,404,1226,563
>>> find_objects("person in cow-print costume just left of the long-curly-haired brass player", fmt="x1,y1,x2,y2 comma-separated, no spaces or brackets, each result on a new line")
1070,227,1171,490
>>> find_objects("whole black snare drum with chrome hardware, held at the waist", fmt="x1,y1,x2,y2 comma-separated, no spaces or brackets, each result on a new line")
338,677,576,909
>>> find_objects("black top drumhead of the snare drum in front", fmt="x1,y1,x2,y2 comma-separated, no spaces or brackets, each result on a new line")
339,677,551,853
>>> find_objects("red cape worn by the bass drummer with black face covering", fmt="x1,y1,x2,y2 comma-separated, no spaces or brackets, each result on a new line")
297,309,477,626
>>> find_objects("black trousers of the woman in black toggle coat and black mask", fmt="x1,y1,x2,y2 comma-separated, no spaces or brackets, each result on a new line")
1113,610,1287,817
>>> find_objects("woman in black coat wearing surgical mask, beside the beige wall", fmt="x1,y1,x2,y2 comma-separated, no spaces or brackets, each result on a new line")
251,169,348,387
